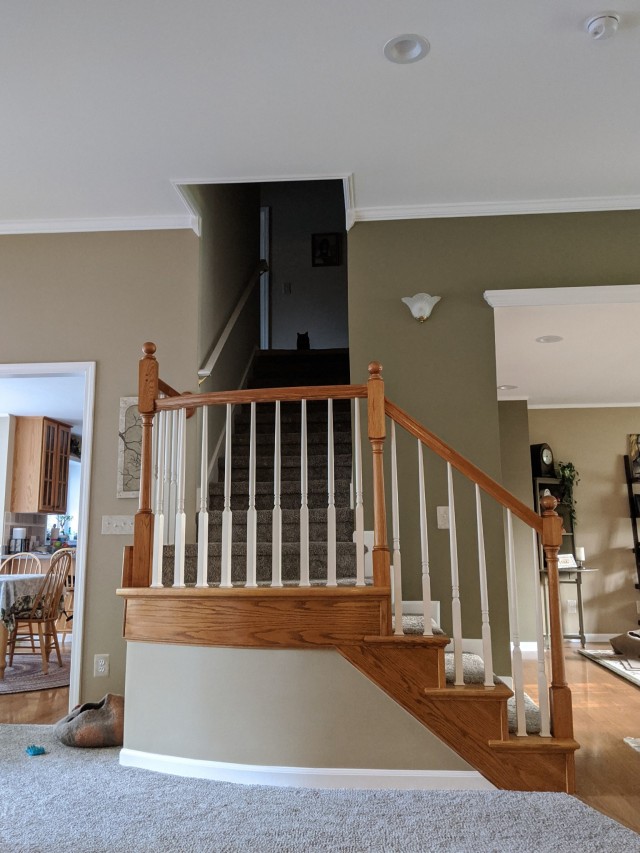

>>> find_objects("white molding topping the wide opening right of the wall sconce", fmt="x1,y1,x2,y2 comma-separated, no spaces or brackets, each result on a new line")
483,284,640,308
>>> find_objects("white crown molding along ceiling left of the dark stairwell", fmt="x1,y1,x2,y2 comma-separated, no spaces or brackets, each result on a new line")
0,214,196,235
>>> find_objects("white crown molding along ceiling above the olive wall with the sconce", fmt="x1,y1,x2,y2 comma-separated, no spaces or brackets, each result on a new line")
354,196,640,222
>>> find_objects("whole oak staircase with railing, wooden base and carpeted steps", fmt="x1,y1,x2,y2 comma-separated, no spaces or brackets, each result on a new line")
120,344,578,792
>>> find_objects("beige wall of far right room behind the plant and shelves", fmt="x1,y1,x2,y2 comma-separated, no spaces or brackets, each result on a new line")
529,406,640,636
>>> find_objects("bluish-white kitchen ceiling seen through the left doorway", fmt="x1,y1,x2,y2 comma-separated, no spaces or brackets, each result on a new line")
0,376,84,435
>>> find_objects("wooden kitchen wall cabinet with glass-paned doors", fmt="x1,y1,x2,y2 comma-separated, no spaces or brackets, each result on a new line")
11,418,71,514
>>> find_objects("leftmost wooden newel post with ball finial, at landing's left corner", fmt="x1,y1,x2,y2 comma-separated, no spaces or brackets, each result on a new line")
131,342,158,587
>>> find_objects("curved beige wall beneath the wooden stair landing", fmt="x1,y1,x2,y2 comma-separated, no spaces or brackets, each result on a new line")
124,643,472,771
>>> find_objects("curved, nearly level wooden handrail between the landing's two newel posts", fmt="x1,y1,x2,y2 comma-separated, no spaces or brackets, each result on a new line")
154,385,367,412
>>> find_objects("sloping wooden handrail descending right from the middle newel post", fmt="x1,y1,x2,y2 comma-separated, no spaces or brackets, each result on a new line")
384,398,542,534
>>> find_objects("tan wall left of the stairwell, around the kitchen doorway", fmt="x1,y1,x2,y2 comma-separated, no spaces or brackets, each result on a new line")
0,226,198,700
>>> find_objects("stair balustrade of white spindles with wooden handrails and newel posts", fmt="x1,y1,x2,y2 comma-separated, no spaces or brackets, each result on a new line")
126,344,572,738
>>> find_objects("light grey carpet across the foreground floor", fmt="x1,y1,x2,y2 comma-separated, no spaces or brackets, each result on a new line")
0,725,640,853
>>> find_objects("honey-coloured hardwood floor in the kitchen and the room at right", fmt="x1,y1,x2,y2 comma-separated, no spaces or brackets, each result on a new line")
0,641,640,832
